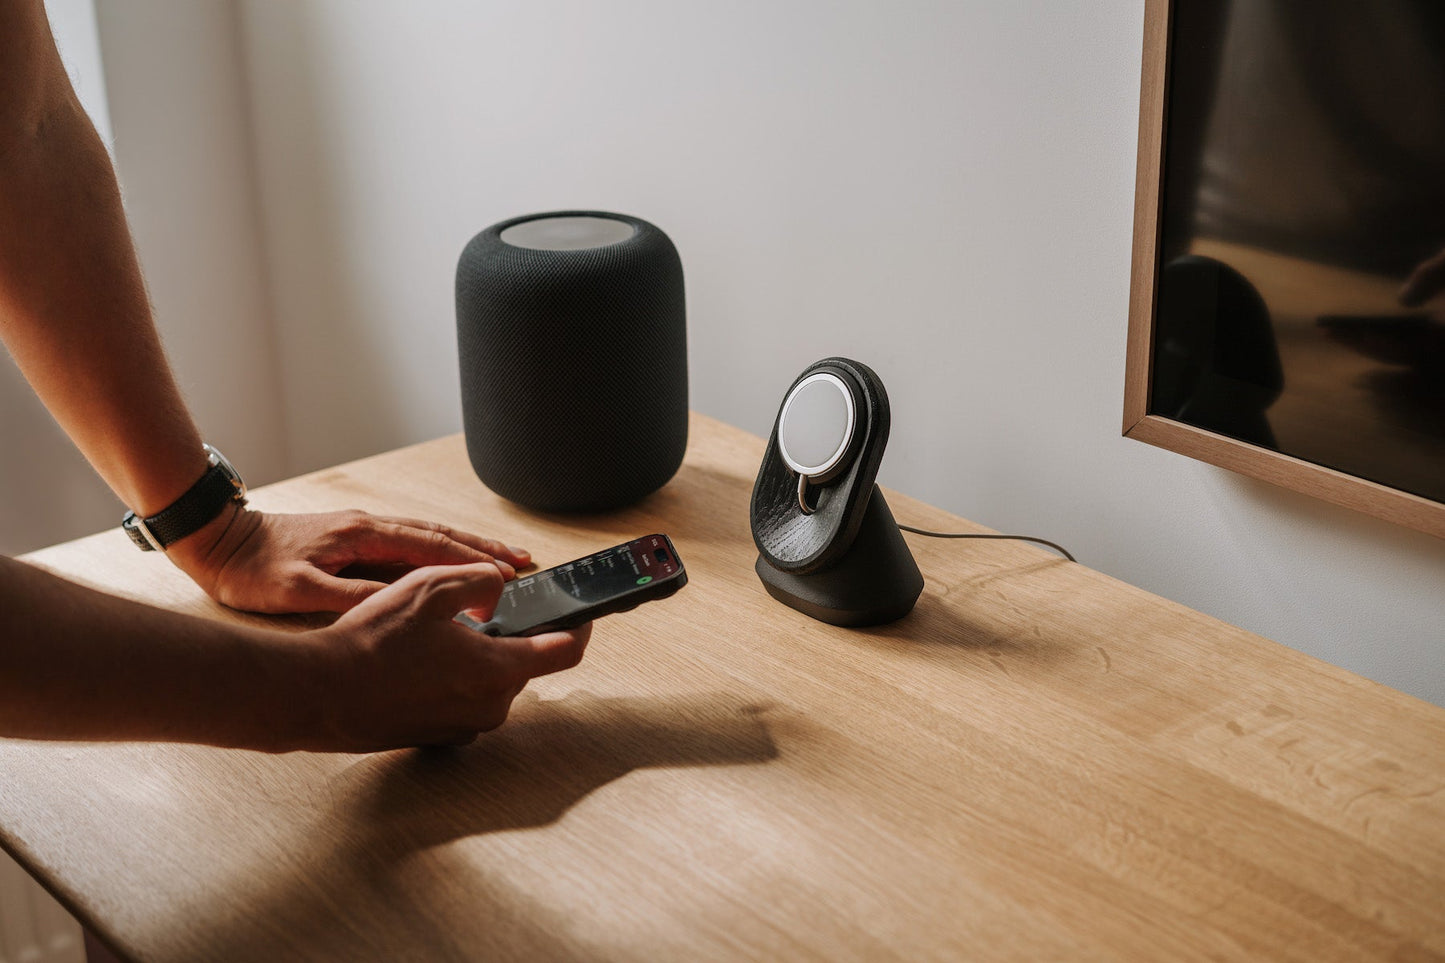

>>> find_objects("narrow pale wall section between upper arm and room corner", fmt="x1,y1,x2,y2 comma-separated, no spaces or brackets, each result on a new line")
95,0,289,484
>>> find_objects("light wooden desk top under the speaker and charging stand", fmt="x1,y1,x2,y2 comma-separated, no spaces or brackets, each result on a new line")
0,418,1445,963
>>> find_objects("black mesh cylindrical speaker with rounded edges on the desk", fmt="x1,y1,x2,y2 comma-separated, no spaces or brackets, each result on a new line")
457,211,688,512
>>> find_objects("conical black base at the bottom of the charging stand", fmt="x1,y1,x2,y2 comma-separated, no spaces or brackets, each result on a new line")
753,486,923,628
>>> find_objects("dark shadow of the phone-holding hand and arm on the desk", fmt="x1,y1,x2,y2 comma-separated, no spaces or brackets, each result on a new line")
159,693,777,960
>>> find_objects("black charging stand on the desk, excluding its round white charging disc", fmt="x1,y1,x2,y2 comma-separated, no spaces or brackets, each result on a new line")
750,357,923,626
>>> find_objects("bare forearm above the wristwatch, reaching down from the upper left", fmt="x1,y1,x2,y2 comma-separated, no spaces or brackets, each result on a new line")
0,3,205,515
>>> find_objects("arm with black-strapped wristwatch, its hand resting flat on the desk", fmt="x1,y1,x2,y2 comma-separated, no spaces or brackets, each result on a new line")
0,0,543,612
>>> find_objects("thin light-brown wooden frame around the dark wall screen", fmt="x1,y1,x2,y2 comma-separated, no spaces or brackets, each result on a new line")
1124,0,1445,538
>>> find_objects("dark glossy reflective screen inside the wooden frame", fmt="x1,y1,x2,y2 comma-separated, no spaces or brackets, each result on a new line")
1150,0,1445,502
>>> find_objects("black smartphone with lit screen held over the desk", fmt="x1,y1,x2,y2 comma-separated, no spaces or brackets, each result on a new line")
457,535,688,636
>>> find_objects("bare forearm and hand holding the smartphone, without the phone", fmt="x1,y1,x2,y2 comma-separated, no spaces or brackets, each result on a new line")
0,557,591,752
